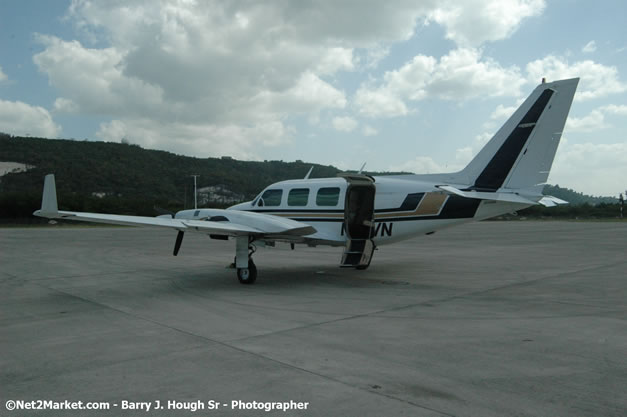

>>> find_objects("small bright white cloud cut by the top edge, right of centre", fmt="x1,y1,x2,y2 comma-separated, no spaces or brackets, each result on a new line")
429,0,545,46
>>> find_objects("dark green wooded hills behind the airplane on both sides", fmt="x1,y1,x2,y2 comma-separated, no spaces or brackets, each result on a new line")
0,134,618,222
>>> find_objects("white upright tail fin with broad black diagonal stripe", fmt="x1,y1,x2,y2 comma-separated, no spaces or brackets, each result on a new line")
459,78,579,191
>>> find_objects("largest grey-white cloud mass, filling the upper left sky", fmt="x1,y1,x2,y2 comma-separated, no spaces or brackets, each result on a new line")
39,0,433,158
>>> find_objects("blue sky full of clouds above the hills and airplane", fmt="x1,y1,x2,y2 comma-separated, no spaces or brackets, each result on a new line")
0,0,627,195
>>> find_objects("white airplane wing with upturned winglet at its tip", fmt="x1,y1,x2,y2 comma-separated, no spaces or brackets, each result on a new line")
33,174,316,237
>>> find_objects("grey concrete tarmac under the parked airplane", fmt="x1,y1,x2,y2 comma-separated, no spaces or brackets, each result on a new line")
0,221,627,417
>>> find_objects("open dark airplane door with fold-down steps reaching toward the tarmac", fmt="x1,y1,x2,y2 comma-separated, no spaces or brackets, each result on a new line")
340,175,376,269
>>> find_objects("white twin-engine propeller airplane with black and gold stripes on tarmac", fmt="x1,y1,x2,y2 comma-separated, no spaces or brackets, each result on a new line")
33,78,579,284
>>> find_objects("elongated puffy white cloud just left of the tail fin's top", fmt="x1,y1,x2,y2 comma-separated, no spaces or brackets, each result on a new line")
355,49,526,117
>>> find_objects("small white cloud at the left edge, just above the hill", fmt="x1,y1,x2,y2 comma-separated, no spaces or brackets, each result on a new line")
0,100,61,138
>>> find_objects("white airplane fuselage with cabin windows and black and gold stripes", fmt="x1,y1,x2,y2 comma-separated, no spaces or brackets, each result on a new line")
176,175,527,246
